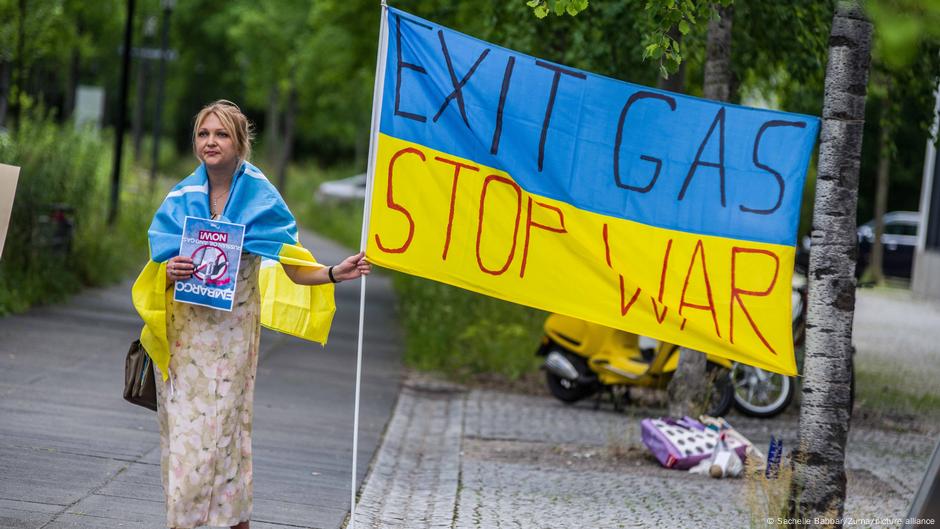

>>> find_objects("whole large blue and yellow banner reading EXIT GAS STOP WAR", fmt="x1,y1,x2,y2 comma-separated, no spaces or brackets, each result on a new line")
367,8,819,375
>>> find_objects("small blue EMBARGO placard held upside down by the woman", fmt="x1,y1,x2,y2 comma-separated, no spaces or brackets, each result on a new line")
173,217,245,311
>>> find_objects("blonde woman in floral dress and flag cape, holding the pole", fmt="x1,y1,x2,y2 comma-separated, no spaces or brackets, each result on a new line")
134,100,371,529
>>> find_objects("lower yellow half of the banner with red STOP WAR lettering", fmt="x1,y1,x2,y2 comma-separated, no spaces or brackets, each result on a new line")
366,134,796,375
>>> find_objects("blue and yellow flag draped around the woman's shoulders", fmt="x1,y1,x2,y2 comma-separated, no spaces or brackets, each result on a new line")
132,162,336,380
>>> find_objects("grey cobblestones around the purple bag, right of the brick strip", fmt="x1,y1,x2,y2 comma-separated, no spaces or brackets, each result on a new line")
455,391,924,529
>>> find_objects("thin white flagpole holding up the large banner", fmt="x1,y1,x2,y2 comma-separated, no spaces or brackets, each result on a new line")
347,0,388,529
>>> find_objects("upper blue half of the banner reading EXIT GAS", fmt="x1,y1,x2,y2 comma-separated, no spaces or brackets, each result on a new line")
378,8,819,245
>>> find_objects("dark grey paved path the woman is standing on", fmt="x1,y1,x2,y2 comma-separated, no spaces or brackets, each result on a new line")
0,234,401,529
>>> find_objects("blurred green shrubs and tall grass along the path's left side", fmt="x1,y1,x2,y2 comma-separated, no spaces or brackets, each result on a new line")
0,112,150,314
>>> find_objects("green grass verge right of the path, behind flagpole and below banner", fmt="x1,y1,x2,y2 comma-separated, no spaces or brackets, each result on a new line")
284,164,546,381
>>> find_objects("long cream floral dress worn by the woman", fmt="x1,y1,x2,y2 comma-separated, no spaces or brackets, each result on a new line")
156,253,261,528
